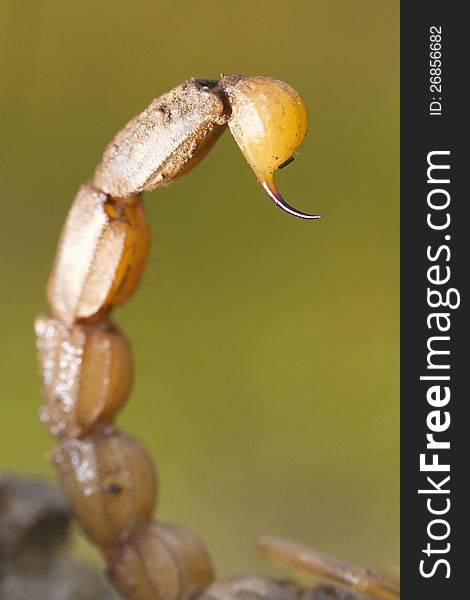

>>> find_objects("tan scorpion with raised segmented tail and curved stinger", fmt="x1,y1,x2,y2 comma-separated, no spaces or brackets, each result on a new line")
36,75,399,600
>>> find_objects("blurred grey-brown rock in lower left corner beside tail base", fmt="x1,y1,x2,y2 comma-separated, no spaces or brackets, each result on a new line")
0,475,119,600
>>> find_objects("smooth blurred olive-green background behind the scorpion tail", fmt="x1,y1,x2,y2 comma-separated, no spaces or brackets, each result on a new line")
0,0,399,575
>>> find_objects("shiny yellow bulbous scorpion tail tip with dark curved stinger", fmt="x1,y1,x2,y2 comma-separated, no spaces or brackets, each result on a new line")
220,75,319,219
